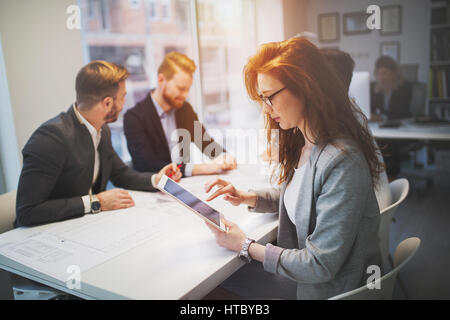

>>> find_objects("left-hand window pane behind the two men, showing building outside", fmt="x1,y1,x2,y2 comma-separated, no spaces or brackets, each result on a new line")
79,0,196,161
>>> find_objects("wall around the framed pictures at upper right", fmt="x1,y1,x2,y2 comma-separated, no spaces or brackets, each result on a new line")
285,0,429,82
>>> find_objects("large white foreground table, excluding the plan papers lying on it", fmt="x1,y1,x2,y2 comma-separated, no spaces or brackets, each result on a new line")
0,165,278,299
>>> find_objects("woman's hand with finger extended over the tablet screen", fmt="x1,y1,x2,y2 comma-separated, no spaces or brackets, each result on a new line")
205,179,256,207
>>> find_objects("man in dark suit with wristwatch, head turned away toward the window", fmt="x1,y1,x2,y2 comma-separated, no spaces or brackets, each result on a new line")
15,61,181,227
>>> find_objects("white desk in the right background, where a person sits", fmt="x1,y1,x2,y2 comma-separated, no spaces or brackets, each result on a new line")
369,119,450,141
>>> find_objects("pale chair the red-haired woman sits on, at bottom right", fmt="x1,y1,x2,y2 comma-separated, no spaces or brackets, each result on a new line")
329,238,420,300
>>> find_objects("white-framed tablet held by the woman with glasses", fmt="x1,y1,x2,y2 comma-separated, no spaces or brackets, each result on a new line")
158,175,226,231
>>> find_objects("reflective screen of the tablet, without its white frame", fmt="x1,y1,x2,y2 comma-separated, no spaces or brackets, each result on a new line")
164,179,220,226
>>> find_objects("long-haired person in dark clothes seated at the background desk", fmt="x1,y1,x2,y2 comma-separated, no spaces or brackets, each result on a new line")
370,56,412,180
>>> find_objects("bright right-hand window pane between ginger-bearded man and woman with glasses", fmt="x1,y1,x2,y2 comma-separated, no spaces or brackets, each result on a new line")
198,0,258,131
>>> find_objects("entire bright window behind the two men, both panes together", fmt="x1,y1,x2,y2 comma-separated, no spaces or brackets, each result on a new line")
79,0,256,161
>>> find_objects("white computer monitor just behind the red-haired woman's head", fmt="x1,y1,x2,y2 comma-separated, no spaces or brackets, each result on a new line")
348,71,370,119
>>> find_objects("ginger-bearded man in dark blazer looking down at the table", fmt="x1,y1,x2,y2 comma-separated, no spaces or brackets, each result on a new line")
123,52,237,176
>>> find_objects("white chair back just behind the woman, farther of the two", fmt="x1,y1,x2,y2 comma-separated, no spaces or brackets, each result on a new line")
378,178,409,266
